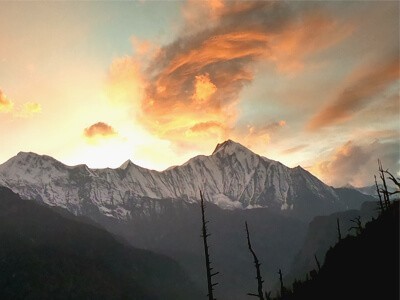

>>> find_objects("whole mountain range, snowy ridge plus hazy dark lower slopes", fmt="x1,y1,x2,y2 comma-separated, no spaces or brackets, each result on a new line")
0,140,375,300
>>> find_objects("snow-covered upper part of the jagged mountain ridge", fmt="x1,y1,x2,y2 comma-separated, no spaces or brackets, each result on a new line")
0,140,344,219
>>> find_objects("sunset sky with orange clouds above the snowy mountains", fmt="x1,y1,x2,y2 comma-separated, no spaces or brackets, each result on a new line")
0,0,400,186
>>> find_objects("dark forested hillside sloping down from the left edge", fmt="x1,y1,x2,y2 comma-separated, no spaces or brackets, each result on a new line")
0,187,201,300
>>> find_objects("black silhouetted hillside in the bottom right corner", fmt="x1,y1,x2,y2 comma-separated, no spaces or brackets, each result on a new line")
279,201,399,300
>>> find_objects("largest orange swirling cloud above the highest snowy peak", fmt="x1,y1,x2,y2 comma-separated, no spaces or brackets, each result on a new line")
111,0,349,152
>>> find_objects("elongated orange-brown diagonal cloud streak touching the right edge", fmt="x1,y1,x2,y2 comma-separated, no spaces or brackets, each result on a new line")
307,54,399,130
